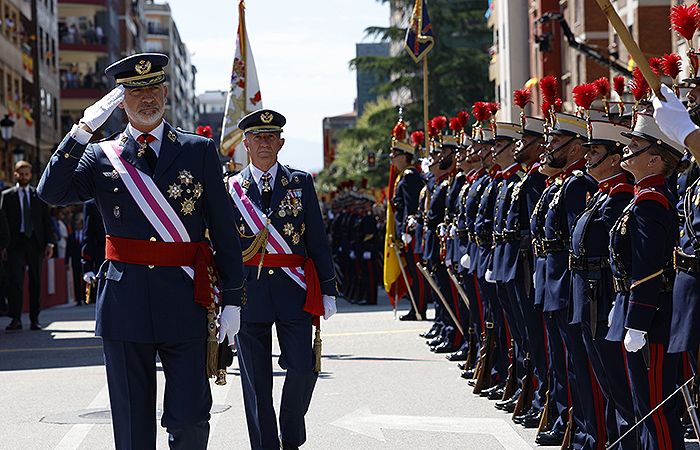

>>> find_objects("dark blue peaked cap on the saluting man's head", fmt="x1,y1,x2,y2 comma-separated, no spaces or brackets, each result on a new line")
105,53,169,88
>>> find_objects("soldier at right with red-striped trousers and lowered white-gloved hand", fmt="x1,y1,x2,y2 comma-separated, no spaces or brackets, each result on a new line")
607,113,684,450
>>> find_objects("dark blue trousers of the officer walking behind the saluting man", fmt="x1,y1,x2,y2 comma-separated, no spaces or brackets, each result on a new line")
236,316,318,450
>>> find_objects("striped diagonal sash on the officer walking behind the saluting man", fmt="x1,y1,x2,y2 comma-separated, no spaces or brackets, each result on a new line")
229,174,306,290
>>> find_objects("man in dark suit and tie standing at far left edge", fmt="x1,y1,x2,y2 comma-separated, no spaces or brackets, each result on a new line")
0,161,55,331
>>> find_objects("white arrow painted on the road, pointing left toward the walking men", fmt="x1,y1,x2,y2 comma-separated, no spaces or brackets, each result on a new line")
331,408,532,450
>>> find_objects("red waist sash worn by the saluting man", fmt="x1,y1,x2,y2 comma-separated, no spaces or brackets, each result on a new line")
105,235,216,308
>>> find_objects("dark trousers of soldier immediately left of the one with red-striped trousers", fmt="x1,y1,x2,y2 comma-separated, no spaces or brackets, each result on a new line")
581,323,639,450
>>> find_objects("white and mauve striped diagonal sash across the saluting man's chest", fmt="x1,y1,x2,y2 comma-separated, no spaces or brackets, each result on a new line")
100,141,194,279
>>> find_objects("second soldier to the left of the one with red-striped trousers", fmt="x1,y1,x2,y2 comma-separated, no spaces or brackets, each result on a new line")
538,113,605,448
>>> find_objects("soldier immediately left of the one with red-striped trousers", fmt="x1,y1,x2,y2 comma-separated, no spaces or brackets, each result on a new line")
569,121,639,449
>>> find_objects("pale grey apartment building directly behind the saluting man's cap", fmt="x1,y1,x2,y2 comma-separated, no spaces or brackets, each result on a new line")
144,2,197,130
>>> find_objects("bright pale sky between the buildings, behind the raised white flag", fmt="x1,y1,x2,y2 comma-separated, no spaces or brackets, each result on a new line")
169,0,389,171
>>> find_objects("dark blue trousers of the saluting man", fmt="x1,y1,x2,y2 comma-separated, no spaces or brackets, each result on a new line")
102,338,211,450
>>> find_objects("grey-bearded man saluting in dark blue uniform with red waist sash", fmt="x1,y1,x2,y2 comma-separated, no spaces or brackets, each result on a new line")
38,53,244,450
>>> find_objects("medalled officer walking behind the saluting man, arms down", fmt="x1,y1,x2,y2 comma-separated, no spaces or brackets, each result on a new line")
219,110,337,450
